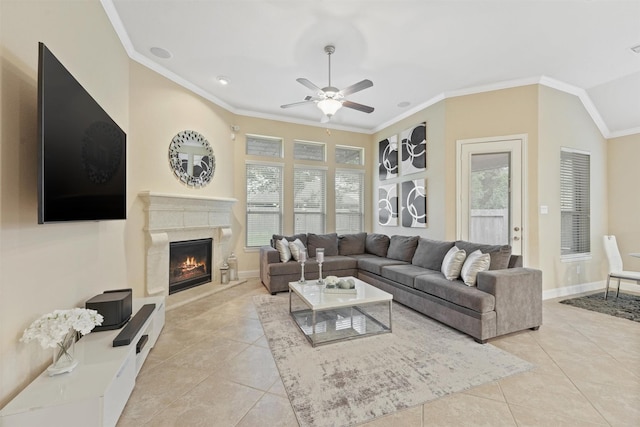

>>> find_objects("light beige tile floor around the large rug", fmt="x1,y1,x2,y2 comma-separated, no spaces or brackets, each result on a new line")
118,279,640,427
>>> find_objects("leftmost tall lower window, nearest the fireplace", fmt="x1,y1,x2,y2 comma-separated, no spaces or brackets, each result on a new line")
246,163,283,247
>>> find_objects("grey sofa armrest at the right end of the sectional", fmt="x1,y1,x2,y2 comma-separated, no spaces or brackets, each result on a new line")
478,267,542,335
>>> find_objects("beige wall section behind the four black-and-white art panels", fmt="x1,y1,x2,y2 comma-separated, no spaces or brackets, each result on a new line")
369,102,448,240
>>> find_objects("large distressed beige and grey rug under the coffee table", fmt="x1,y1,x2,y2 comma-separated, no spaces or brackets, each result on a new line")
253,295,533,427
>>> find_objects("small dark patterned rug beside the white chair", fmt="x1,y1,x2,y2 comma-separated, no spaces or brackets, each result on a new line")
560,291,640,322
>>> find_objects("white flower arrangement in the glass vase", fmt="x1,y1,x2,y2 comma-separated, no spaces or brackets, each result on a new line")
20,308,104,348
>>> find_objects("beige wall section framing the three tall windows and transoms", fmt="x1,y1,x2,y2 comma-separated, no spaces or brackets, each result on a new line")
232,116,373,275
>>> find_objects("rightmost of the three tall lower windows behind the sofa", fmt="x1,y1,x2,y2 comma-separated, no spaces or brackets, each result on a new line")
336,169,364,234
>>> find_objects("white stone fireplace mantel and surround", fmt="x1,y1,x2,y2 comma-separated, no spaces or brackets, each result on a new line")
139,191,237,295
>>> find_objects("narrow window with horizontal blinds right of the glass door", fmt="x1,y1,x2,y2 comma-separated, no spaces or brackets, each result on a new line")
560,148,591,257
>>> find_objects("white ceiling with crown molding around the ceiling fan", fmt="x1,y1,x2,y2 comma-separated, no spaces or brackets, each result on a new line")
102,0,640,137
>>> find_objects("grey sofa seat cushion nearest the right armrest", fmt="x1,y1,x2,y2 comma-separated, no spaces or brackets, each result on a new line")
413,274,496,313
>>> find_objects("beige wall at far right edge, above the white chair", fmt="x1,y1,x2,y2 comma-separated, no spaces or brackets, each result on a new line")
606,134,640,271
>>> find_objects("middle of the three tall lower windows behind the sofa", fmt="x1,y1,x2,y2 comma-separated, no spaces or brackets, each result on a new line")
293,167,327,234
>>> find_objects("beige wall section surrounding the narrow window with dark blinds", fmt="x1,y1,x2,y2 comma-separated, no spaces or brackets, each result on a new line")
537,86,608,292
